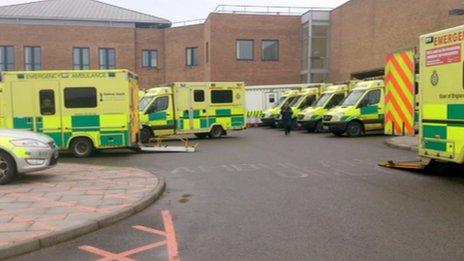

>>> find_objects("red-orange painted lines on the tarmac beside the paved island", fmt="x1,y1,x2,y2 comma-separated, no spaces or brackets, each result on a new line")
79,210,180,261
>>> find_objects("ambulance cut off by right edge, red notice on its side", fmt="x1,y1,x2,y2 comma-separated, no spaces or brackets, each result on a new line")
419,26,464,164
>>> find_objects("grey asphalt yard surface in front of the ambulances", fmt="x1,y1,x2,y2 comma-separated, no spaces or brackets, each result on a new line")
10,128,464,260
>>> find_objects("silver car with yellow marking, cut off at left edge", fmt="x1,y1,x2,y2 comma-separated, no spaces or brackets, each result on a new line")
0,129,58,185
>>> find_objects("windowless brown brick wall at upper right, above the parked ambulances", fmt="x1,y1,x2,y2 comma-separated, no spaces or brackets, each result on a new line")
330,0,464,81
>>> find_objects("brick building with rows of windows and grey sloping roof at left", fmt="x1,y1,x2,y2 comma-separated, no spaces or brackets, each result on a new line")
0,0,306,88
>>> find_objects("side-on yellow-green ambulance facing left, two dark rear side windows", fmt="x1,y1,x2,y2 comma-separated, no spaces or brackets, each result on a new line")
139,82,246,143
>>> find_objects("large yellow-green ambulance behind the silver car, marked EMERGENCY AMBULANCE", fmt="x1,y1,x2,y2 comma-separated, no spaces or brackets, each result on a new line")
0,70,140,157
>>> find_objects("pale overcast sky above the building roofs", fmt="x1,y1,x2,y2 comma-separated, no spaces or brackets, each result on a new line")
0,0,348,22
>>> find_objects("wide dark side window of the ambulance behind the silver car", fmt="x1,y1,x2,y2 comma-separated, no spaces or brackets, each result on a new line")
64,87,97,108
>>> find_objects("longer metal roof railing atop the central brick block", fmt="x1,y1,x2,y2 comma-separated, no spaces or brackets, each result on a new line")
214,5,333,15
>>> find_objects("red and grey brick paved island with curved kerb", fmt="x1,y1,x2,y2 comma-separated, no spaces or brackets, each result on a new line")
0,164,165,260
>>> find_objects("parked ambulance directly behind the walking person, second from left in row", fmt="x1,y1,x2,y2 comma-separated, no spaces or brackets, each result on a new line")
276,85,325,127
